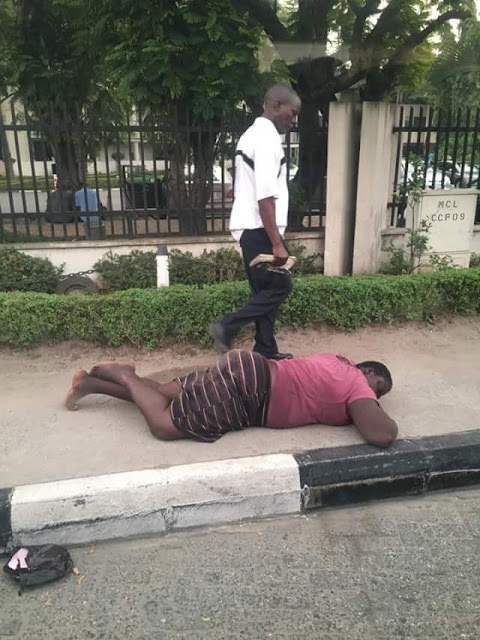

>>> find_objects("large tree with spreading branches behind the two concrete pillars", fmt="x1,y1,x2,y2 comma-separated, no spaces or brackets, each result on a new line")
233,0,472,226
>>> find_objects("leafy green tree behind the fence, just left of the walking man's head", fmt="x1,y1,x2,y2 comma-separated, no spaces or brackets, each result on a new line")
92,0,270,233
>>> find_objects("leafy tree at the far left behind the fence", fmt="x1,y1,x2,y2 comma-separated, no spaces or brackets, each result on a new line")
0,0,125,189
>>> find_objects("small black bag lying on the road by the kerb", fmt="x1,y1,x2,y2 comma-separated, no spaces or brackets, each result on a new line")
3,544,73,592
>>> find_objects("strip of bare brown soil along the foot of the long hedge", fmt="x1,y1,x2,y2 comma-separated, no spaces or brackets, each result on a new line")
0,316,480,378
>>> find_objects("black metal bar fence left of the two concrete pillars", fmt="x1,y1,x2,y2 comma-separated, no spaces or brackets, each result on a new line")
0,102,326,242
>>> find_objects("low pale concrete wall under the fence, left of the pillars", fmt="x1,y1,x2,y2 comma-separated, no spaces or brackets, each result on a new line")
14,231,324,279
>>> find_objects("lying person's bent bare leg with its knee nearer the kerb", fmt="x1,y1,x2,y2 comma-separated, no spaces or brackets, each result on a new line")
88,362,185,440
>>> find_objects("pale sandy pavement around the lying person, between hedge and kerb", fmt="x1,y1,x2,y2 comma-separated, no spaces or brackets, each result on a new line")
0,318,480,488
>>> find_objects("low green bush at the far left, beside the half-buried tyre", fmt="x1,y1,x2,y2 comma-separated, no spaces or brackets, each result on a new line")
0,247,63,293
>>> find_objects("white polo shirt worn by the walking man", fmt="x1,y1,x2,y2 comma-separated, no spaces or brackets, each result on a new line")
230,117,288,241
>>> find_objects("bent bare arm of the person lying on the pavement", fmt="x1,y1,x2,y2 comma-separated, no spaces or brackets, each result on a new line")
348,398,398,447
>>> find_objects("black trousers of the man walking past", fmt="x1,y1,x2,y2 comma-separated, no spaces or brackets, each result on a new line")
221,229,292,358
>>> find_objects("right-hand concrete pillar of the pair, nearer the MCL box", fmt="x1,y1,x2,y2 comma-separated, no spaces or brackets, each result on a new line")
350,102,399,275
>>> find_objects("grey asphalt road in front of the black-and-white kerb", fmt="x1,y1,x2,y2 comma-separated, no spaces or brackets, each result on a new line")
0,490,480,640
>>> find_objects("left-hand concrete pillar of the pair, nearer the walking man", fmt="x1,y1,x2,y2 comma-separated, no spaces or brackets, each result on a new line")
324,102,362,276
